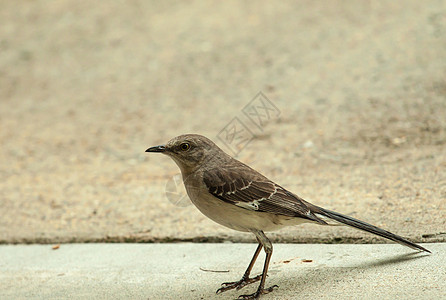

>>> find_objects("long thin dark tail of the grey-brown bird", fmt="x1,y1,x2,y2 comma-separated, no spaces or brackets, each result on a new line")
311,205,431,253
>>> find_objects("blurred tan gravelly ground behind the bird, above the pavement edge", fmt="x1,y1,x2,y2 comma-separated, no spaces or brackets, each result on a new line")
0,0,446,243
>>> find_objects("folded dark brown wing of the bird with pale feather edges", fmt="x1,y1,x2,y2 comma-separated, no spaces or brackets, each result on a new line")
203,168,327,225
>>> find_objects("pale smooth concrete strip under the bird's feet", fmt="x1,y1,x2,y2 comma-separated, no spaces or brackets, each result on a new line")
0,243,446,300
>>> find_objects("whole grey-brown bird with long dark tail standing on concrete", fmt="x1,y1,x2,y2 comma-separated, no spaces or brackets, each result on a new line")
146,134,430,299
